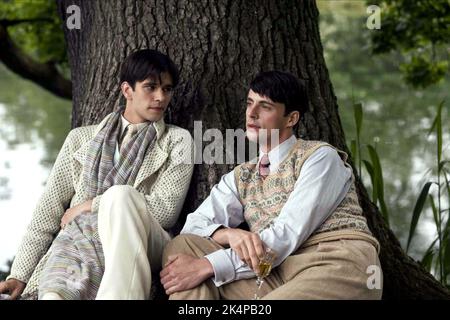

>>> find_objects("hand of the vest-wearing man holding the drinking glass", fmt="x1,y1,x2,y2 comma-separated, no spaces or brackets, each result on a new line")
212,228,264,273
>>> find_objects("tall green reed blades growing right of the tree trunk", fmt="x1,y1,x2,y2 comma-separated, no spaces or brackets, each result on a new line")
352,101,450,288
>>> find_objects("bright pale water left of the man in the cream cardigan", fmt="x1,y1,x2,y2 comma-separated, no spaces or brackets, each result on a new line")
0,64,71,269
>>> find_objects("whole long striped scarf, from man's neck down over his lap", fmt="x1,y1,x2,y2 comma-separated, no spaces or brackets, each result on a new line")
39,108,156,300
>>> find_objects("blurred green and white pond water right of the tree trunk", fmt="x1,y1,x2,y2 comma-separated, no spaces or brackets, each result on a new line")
318,1,450,260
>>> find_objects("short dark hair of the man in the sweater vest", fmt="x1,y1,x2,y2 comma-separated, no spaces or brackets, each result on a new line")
250,70,308,117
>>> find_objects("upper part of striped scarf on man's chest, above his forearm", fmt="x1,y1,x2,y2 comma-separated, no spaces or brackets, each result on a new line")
84,107,156,199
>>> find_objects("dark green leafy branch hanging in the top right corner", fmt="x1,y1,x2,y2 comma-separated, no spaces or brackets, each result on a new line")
367,0,450,88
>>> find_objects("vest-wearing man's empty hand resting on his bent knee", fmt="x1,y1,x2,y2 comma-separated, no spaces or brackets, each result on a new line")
159,254,214,295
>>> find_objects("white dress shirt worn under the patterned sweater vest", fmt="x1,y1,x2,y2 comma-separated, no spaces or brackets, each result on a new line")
181,135,352,286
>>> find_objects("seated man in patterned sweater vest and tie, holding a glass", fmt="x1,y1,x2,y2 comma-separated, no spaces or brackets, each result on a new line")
160,71,382,299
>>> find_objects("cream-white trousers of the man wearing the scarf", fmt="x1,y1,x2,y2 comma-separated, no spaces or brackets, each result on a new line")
96,185,171,300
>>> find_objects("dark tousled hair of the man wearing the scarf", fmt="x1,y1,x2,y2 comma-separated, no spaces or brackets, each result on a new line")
120,49,179,90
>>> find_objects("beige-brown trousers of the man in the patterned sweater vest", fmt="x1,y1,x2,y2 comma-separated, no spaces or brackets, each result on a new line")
163,235,382,300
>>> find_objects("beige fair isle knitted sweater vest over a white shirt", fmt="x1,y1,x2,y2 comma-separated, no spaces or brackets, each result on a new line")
234,139,371,236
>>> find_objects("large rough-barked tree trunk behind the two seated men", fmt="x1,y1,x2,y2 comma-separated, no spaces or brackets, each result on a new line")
58,0,450,299
